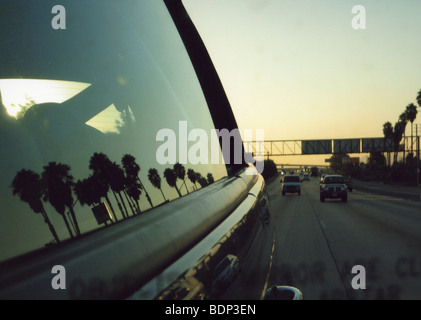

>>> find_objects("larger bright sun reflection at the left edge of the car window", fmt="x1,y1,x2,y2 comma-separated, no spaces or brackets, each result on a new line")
0,79,91,118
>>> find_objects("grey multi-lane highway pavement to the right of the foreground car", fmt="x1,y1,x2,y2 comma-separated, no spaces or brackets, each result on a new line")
267,177,421,300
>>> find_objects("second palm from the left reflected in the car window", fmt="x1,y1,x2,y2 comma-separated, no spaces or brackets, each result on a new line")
41,162,80,237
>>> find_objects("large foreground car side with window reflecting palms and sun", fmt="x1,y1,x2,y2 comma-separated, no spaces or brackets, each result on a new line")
0,0,298,299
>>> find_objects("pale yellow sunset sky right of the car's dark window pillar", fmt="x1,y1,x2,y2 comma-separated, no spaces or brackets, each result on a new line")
184,0,421,164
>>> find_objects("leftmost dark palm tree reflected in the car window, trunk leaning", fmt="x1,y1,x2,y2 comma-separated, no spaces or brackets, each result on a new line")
12,169,60,242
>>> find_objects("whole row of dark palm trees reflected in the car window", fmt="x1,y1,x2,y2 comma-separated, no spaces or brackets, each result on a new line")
11,153,214,243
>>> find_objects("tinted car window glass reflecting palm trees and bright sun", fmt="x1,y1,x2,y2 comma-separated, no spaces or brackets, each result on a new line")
0,0,226,260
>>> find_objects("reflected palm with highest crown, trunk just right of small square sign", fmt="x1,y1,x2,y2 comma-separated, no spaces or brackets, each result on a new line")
89,152,118,221
